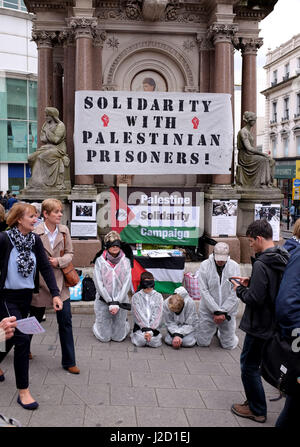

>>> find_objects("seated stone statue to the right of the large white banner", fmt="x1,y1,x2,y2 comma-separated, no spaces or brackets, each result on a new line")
236,112,275,188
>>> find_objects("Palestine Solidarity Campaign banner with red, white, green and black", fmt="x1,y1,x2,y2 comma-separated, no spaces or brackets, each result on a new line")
110,187,204,246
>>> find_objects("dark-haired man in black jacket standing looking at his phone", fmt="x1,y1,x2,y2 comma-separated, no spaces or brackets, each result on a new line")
231,219,289,422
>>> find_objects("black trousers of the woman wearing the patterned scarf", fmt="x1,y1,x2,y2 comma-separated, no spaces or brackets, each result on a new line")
0,289,32,390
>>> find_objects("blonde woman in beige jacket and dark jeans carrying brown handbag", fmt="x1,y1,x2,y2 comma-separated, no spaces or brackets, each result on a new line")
30,199,80,374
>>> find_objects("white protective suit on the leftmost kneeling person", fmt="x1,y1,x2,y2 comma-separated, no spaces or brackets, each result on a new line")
93,252,131,342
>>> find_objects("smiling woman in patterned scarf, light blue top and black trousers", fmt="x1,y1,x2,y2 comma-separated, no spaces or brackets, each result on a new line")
0,202,62,410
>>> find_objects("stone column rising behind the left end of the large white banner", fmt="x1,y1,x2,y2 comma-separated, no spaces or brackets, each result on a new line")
67,17,97,185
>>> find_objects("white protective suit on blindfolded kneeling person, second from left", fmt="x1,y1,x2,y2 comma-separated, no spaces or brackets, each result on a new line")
130,289,163,348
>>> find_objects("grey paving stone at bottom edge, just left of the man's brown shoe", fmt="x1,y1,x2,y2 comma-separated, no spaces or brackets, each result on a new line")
185,408,239,427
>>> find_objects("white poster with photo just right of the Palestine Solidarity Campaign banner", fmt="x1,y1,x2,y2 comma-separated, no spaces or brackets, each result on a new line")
212,200,238,237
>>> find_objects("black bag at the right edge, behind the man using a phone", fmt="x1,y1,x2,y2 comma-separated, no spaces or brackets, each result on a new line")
261,332,300,396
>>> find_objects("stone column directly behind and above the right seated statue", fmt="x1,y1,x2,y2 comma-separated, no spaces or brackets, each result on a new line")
238,37,263,140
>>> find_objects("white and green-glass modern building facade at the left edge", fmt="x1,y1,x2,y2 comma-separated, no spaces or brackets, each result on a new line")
0,0,37,193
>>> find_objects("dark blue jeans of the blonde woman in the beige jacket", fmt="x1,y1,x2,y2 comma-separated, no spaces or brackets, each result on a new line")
30,298,76,368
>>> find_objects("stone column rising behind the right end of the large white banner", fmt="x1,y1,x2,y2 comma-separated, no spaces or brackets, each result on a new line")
209,23,237,185
